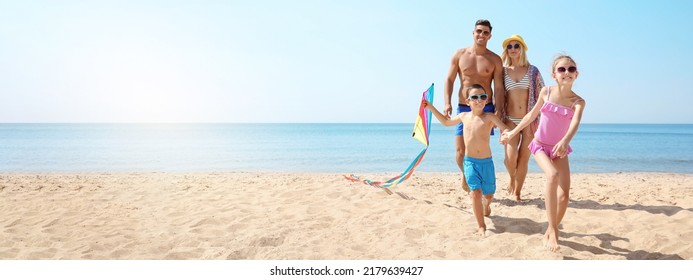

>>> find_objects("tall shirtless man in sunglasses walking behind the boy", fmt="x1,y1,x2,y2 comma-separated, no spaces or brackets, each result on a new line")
443,19,505,192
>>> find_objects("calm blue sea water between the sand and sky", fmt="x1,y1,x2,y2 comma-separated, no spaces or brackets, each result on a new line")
0,123,693,173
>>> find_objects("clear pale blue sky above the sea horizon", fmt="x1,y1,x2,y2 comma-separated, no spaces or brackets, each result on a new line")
0,0,693,123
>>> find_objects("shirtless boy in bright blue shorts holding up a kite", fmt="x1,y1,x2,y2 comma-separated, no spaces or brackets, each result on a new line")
422,84,507,237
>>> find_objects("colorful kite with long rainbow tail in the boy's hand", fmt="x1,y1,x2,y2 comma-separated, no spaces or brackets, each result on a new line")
344,84,433,188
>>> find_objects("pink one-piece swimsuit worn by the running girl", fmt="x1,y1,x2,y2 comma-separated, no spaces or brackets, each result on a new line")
528,87,582,159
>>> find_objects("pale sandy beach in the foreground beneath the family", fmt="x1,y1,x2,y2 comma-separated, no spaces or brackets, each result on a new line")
0,172,693,260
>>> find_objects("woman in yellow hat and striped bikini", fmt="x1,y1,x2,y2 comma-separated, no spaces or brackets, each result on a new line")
501,34,544,201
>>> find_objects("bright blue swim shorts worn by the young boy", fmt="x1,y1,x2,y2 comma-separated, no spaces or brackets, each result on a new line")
462,156,496,195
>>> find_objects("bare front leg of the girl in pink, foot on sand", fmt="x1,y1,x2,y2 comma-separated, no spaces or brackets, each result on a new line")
534,151,559,252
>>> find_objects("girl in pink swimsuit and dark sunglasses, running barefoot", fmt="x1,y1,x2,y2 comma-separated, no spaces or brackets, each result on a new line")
501,55,585,252
